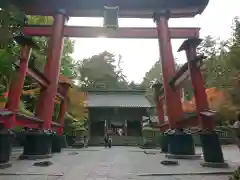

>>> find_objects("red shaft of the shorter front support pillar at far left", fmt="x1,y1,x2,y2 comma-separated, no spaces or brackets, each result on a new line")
5,40,32,128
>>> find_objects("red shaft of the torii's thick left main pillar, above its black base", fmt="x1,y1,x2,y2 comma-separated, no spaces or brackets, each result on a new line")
36,10,67,129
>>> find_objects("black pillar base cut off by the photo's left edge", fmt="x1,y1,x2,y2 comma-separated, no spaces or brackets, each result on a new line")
0,130,12,167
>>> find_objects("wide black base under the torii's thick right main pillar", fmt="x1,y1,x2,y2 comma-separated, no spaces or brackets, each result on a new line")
168,130,195,156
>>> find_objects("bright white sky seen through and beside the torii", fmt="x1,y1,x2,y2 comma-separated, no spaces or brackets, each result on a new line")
68,0,240,83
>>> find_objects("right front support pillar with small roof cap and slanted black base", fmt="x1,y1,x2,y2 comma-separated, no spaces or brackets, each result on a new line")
178,38,228,168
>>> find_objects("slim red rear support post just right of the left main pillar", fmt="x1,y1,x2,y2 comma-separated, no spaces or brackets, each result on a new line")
57,83,70,135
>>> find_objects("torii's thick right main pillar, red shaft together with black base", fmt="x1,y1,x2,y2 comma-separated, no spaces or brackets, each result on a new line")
153,10,195,157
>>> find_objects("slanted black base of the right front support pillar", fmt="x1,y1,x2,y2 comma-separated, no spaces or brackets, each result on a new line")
200,132,226,168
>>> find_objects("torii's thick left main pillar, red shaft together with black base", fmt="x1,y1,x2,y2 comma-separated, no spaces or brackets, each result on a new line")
23,10,67,159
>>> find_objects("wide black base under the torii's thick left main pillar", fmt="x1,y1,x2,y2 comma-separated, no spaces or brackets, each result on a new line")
21,130,52,159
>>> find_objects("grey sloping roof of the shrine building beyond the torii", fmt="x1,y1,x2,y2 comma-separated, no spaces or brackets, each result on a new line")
86,91,152,108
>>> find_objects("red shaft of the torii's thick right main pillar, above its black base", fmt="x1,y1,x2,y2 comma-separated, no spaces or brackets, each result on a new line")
154,11,183,128
